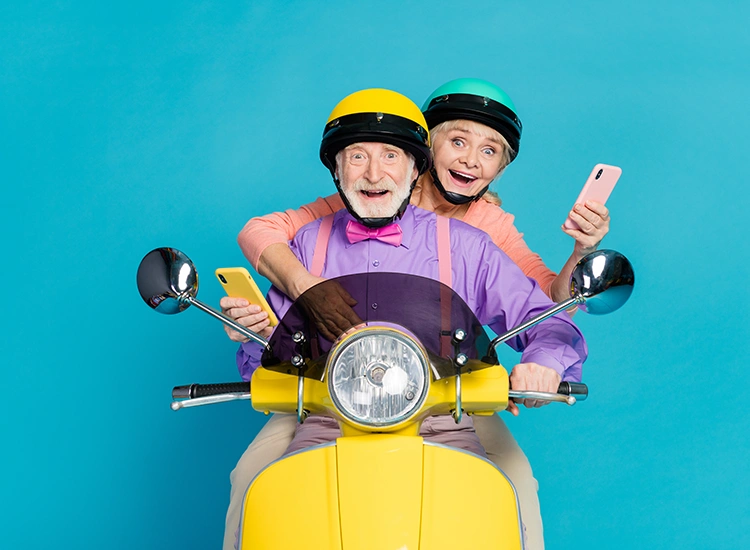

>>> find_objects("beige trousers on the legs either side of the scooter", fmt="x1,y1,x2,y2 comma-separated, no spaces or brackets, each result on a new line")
223,414,544,550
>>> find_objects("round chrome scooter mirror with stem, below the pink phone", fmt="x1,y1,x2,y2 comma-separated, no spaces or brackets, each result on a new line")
488,250,635,355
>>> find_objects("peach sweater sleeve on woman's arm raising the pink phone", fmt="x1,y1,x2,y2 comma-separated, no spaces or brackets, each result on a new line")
463,200,557,296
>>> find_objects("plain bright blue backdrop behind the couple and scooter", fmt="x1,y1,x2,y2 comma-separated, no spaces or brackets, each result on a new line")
0,0,750,549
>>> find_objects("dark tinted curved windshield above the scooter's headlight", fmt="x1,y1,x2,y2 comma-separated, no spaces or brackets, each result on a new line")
261,273,494,380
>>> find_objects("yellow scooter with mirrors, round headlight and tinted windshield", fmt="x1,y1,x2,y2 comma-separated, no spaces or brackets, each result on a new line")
138,248,634,550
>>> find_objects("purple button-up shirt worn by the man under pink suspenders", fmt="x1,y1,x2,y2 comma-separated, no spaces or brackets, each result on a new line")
237,205,587,381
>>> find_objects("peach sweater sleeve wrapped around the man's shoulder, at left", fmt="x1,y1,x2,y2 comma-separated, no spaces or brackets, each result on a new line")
237,193,344,269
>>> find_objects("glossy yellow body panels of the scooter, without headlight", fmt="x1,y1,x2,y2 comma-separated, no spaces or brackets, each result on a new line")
240,366,523,550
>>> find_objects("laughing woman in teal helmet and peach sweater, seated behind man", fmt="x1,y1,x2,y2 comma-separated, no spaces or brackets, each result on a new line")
221,79,609,549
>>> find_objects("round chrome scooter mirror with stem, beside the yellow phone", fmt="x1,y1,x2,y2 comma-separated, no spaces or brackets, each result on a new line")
136,247,268,348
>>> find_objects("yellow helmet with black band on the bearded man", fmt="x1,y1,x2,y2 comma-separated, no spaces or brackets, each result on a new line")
320,88,432,178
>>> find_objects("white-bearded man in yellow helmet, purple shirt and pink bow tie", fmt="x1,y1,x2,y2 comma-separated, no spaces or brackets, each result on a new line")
222,90,586,548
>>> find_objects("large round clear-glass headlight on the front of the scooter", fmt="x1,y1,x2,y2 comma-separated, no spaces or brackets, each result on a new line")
328,327,429,432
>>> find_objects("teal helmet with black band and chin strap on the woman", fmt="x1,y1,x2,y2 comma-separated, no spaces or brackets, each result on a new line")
422,78,522,204
